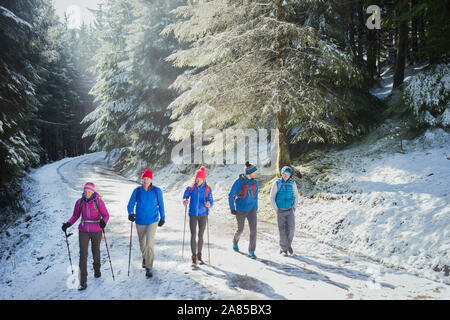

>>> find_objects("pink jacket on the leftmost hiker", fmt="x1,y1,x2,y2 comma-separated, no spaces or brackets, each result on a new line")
67,193,109,232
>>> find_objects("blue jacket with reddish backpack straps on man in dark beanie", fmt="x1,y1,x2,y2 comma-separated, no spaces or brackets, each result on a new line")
228,175,258,212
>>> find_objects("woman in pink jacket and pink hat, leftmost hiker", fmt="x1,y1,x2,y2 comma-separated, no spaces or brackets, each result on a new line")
62,182,109,290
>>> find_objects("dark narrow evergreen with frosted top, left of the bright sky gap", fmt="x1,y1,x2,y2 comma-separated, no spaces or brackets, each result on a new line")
36,3,83,163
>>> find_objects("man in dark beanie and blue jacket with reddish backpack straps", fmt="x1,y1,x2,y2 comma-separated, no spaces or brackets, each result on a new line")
228,161,258,259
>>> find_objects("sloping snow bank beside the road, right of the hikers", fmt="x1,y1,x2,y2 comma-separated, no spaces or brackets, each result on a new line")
297,123,450,283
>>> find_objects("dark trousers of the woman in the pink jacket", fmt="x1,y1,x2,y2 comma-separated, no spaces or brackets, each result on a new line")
78,231,102,286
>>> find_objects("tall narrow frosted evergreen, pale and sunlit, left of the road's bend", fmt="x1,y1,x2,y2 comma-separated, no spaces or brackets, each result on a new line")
83,0,133,153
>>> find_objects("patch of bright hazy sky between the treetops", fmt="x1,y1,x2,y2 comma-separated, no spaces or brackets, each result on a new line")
52,0,101,28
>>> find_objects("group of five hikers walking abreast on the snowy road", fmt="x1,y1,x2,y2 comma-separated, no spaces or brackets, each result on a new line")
62,162,299,290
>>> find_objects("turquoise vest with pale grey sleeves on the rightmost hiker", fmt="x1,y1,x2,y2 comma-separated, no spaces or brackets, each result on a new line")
270,178,299,211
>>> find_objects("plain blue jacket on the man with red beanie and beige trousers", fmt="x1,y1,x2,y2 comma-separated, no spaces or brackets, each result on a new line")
127,185,166,226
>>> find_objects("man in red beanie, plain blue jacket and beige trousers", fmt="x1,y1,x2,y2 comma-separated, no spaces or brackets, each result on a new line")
127,169,165,278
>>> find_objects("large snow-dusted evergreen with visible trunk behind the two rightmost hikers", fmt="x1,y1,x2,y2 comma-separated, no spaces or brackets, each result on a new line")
164,0,361,172
